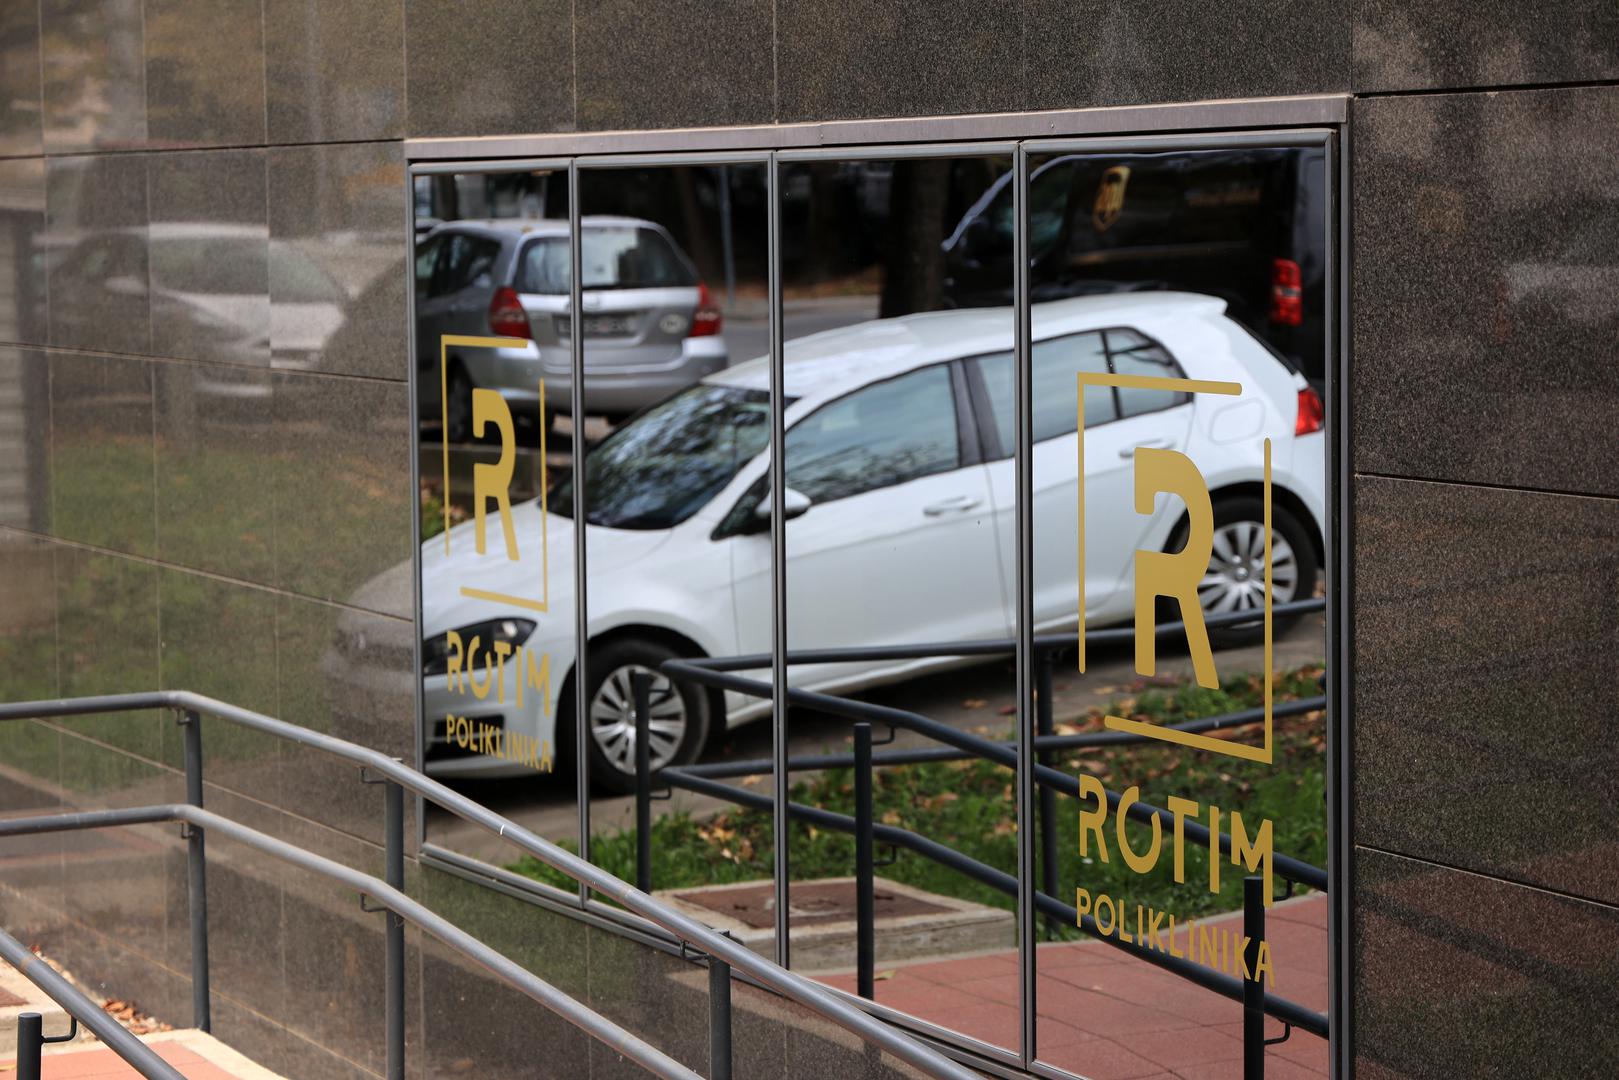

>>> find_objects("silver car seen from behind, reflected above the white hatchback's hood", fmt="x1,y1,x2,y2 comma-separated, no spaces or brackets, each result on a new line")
416,217,727,442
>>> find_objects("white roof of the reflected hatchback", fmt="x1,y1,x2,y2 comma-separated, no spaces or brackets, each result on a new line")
704,291,1226,398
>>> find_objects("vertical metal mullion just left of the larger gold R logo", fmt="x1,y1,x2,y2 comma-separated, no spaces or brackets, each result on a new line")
1012,146,1036,1065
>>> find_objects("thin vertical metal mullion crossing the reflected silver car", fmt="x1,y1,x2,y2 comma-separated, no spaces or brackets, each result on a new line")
573,160,591,904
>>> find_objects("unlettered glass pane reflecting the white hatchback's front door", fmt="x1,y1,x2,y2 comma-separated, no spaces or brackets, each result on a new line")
780,148,1016,1049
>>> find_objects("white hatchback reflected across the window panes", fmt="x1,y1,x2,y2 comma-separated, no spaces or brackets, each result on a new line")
421,293,1326,789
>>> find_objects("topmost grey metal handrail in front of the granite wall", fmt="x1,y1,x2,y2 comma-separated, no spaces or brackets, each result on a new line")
0,690,976,1080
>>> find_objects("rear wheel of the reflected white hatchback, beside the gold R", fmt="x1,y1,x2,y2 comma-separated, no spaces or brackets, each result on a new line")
1159,495,1319,649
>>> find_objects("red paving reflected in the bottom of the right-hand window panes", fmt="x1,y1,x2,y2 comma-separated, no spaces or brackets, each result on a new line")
822,894,1329,1080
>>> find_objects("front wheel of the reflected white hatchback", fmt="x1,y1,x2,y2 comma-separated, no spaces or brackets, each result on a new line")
584,638,712,793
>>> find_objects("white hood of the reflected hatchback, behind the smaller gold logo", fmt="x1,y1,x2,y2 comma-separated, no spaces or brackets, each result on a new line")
421,500,672,638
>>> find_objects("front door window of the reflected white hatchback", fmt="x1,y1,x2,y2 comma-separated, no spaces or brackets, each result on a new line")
787,364,962,502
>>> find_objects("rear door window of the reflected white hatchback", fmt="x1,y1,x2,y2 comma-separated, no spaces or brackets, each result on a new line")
968,330,1119,458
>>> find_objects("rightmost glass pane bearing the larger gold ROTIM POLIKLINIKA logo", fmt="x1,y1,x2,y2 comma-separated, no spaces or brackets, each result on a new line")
1026,147,1328,1080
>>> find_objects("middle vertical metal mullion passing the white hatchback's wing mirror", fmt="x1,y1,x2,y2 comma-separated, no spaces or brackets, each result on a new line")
766,154,790,968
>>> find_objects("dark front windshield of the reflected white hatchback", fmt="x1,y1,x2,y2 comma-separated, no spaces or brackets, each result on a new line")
549,382,771,529
